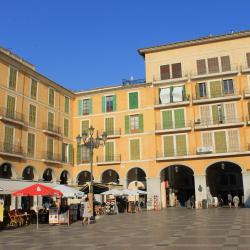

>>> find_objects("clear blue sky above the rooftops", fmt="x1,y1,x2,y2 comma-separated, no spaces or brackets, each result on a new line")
0,0,250,89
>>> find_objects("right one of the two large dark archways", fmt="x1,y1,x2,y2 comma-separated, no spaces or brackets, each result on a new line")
206,161,244,205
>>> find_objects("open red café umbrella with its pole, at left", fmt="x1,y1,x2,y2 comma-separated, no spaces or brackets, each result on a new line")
12,183,63,229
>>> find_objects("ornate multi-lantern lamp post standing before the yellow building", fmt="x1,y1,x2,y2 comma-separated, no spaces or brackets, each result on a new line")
76,126,107,216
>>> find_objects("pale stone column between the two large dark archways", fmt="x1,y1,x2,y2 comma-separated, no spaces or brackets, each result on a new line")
194,175,207,208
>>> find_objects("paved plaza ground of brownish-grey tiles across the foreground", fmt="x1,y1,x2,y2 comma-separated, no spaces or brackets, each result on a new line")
0,208,250,250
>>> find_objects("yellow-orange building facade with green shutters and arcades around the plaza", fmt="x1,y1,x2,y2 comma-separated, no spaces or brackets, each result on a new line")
0,31,250,207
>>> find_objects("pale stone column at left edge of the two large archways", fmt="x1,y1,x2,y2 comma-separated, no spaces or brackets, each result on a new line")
147,177,161,210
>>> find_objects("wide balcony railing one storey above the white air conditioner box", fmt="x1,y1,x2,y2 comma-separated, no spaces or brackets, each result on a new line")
194,116,244,128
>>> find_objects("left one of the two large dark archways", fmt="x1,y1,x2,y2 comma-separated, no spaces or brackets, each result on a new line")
161,165,195,207
